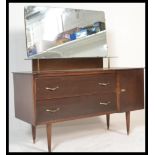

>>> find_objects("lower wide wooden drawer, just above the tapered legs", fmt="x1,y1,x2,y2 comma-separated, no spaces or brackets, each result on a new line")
37,93,116,124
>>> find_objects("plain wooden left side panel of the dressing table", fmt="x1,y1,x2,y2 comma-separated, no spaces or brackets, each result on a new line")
13,73,35,125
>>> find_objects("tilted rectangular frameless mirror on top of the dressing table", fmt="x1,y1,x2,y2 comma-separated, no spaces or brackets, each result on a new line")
24,6,108,59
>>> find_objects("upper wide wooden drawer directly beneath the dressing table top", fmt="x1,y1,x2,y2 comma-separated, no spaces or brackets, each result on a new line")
36,74,115,100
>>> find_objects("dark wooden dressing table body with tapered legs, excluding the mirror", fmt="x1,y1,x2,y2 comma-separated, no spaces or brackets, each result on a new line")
13,6,144,152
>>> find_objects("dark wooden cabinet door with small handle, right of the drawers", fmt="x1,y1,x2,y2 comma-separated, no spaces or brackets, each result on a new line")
118,69,144,111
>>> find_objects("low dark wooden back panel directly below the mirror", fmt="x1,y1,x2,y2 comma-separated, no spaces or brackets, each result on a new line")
32,58,103,71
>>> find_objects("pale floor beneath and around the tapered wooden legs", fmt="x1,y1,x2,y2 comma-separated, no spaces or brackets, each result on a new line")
9,110,145,152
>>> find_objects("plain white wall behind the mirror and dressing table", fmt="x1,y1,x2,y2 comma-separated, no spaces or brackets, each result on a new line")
9,3,145,153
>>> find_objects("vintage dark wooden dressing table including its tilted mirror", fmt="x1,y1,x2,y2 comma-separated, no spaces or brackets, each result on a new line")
13,7,144,152
